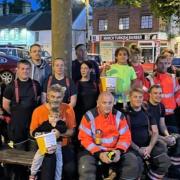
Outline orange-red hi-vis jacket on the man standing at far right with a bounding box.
[143,73,180,115]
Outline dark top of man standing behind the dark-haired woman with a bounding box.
[72,59,100,83]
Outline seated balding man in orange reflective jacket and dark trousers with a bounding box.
[78,92,139,180]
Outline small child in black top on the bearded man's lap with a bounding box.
[29,108,67,180]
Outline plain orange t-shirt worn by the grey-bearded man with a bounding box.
[30,103,76,146]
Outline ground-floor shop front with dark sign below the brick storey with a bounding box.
[91,33,168,63]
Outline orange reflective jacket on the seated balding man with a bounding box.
[78,108,131,154]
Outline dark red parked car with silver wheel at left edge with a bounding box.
[0,55,18,84]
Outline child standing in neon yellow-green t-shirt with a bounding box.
[102,47,136,110]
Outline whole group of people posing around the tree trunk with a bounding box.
[0,44,180,180]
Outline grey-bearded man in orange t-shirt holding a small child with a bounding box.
[30,84,76,180]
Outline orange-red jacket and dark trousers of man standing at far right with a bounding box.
[143,72,180,133]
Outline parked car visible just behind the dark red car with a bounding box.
[0,46,29,59]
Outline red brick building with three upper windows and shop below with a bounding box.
[91,5,168,61]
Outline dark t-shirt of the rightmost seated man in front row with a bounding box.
[147,102,165,132]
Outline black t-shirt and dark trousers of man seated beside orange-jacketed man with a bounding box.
[126,106,171,180]
